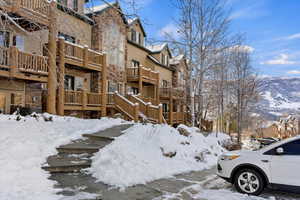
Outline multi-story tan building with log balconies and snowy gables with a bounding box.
[0,0,187,124]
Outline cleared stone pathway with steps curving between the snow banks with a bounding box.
[43,125,300,200]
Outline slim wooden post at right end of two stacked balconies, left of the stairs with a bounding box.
[99,54,107,117]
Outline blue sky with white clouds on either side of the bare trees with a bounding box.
[91,0,300,77]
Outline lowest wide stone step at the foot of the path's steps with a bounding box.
[42,153,92,173]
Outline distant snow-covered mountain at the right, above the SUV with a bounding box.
[255,78,300,120]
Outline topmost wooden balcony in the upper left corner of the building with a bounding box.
[2,0,50,27]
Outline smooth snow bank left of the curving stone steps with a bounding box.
[0,114,127,200]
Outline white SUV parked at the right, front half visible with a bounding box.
[217,136,300,195]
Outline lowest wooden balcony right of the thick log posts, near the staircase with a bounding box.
[64,90,102,111]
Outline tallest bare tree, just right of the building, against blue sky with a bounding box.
[166,0,230,125]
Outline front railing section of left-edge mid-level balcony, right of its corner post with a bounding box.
[18,51,48,75]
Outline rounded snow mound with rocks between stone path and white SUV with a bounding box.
[89,124,228,189]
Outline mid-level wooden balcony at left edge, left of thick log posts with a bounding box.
[0,46,48,82]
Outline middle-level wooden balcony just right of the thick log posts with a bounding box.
[55,40,103,71]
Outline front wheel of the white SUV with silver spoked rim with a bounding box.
[234,169,265,195]
